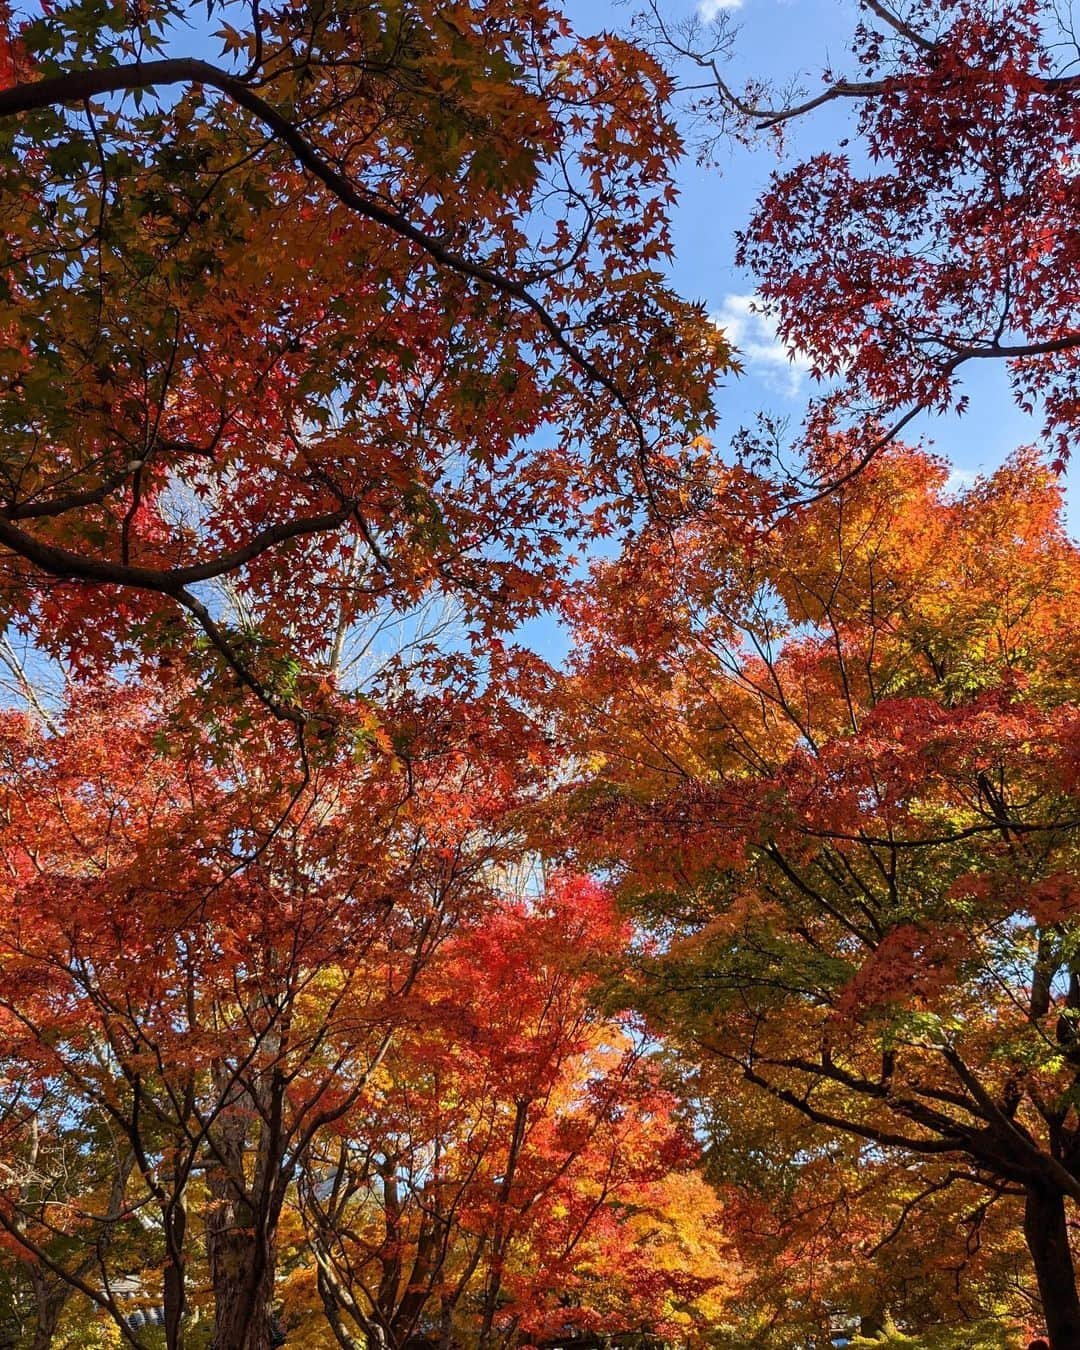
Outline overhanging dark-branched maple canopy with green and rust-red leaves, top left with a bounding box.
[0,0,726,721]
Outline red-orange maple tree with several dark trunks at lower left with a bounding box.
[0,675,556,1350]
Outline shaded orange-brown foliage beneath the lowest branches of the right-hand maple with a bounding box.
[684,1090,1031,1350]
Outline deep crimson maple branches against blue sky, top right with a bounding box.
[648,0,1080,479]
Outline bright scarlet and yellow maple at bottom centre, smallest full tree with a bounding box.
[291,878,737,1350]
